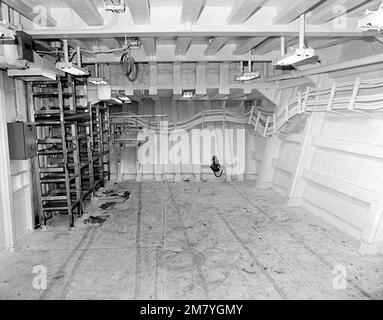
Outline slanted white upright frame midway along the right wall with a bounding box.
[287,112,326,207]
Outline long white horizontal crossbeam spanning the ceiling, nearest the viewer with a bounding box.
[28,21,376,39]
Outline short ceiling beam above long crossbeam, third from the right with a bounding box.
[226,0,268,24]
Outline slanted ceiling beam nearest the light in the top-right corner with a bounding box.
[307,0,370,24]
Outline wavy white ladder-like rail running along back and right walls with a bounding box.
[111,78,383,138]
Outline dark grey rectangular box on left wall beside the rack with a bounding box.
[8,122,37,160]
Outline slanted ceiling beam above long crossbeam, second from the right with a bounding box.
[273,0,325,24]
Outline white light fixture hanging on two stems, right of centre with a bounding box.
[274,14,316,67]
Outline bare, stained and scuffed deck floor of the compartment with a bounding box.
[0,182,383,300]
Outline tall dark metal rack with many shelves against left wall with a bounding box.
[30,76,110,227]
